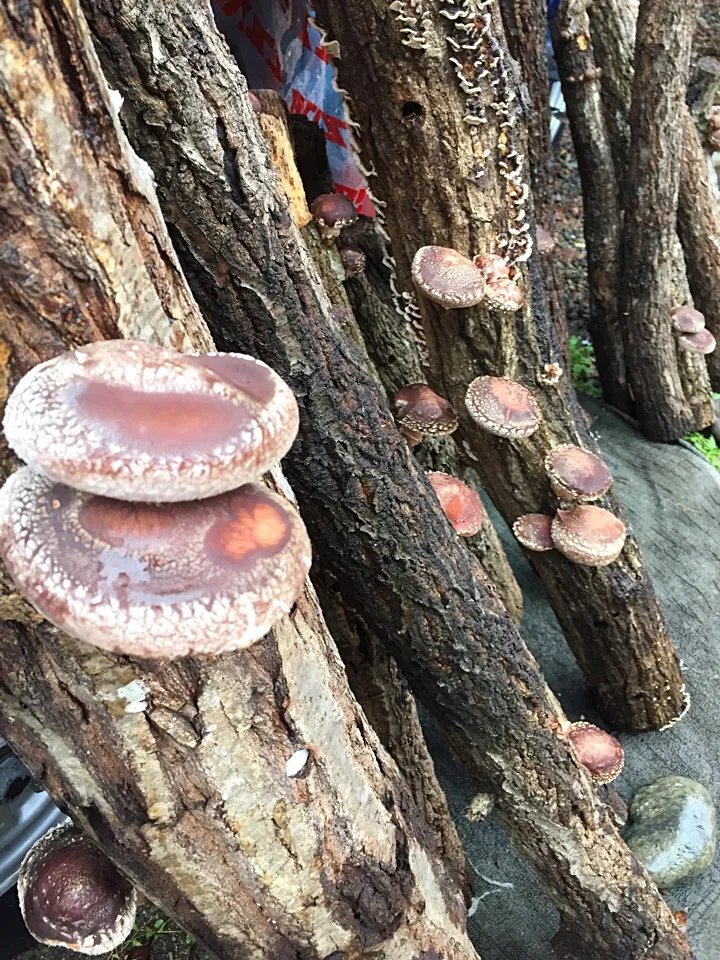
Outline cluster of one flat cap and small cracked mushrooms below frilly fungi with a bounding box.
[412,246,523,313]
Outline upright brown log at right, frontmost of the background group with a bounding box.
[618,0,715,441]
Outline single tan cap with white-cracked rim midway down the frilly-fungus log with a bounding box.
[465,377,540,440]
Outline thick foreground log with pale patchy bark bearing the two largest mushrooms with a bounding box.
[0,0,476,960]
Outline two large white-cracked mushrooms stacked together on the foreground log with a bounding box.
[0,341,310,658]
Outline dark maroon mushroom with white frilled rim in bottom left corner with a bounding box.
[18,824,137,955]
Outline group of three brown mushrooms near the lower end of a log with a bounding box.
[513,444,627,567]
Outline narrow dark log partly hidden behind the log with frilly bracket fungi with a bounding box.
[500,0,570,370]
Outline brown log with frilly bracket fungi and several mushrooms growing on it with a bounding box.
[317,0,683,730]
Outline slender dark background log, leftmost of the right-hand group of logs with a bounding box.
[553,7,632,412]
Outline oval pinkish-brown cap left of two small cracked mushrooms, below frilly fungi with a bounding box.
[412,247,485,310]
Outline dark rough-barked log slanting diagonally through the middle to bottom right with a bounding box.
[80,0,689,948]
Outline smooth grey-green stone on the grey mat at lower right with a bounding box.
[625,776,716,890]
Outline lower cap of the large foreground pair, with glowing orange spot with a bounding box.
[0,467,311,658]
